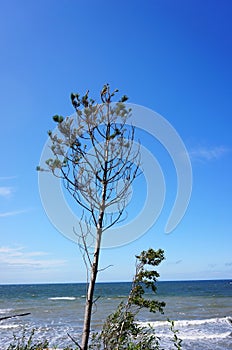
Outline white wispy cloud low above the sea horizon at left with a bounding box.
[0,247,66,269]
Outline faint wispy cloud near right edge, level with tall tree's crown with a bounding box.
[188,146,231,161]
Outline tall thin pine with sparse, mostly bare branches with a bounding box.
[37,84,140,350]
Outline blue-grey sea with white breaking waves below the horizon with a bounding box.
[0,280,232,350]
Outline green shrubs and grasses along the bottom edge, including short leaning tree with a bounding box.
[7,248,182,350]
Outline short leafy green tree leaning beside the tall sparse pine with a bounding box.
[91,248,167,350]
